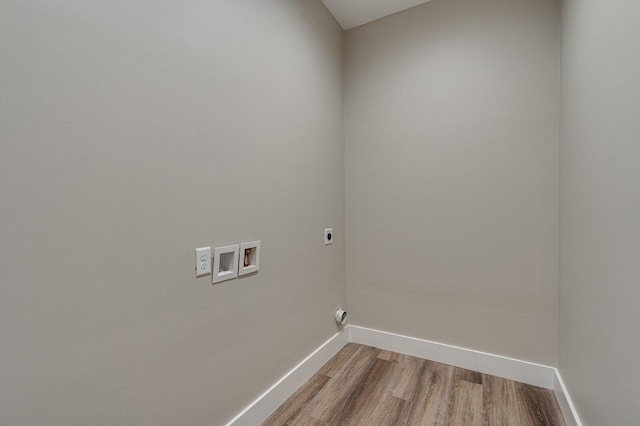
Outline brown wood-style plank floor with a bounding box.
[263,343,565,426]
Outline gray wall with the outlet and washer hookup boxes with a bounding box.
[0,0,346,425]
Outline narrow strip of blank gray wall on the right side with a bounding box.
[559,0,640,426]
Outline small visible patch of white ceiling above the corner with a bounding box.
[322,0,431,30]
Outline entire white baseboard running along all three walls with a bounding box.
[226,325,582,426]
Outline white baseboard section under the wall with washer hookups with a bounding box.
[222,331,349,426]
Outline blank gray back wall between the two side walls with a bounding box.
[345,0,559,365]
